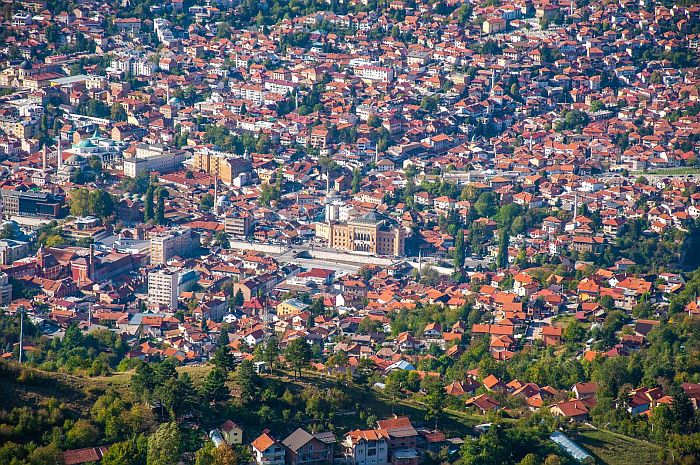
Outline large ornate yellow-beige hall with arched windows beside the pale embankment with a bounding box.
[316,212,406,257]
